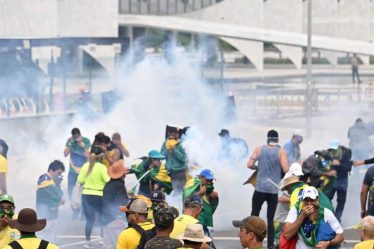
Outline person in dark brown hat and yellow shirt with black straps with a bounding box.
[3,208,58,249]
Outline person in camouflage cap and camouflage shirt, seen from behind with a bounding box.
[145,207,182,249]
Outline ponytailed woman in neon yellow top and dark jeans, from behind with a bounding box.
[78,146,110,248]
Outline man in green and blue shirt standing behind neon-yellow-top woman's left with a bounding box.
[64,128,91,218]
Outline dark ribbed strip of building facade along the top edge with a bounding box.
[119,0,223,15]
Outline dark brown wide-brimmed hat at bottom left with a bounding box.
[8,208,47,232]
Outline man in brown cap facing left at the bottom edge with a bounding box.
[232,216,267,249]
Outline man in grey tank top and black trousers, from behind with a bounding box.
[247,130,288,248]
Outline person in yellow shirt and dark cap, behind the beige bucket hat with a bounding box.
[170,194,204,239]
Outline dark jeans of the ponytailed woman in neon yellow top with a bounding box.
[82,194,103,240]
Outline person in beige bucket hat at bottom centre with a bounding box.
[178,224,212,249]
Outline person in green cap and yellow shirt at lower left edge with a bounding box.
[0,195,21,248]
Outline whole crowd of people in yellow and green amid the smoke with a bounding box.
[0,119,374,249]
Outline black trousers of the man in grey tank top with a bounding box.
[251,190,278,248]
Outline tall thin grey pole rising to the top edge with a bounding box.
[306,0,312,137]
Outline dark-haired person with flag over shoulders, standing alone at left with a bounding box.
[36,160,65,241]
